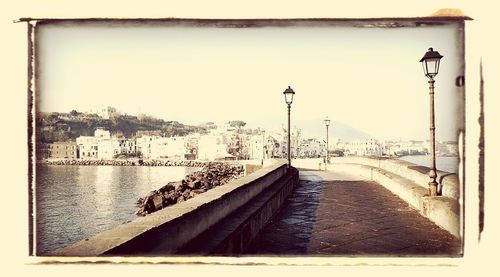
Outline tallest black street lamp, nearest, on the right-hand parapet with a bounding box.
[420,48,443,196]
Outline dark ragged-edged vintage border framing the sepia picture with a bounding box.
[20,8,480,264]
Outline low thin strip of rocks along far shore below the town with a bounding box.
[43,159,210,167]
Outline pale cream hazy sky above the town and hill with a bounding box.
[37,24,460,140]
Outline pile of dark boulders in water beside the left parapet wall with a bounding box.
[136,162,244,216]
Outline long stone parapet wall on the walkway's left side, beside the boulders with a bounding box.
[48,162,289,256]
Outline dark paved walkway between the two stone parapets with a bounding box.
[245,171,461,256]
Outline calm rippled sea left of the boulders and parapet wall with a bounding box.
[35,165,199,254]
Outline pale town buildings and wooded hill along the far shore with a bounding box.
[36,106,458,161]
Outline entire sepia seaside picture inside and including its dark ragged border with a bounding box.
[25,10,470,257]
